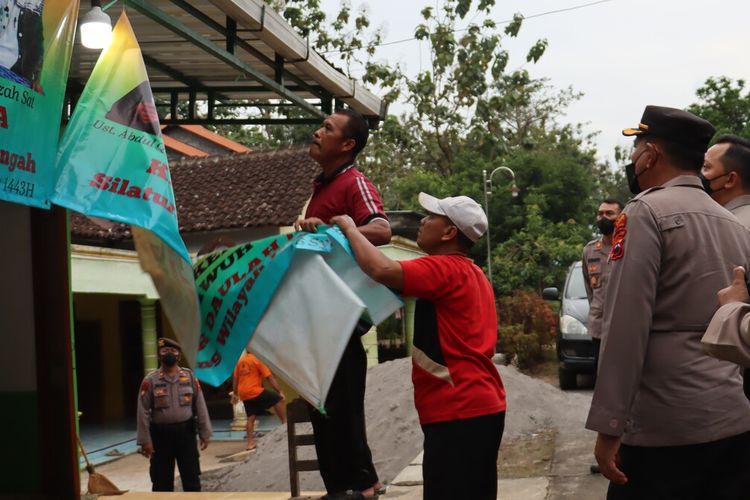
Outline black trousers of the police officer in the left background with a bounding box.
[149,419,201,491]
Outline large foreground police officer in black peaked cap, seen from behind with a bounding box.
[586,106,750,500]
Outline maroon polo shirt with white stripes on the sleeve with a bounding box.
[305,163,388,226]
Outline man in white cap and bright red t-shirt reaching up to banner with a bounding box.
[331,193,505,500]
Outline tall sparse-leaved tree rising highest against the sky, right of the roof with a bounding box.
[364,0,547,176]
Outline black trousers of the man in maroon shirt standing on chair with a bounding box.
[310,333,378,494]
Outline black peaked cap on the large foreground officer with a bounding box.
[622,106,716,151]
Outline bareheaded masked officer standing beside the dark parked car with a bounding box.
[583,198,623,376]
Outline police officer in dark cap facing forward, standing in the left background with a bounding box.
[137,338,212,491]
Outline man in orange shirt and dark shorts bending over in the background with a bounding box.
[232,351,286,451]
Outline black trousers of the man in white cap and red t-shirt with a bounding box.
[422,412,505,500]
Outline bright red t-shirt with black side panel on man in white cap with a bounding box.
[399,255,505,424]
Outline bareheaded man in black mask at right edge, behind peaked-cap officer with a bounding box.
[701,135,750,399]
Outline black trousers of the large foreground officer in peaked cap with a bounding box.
[607,432,750,500]
